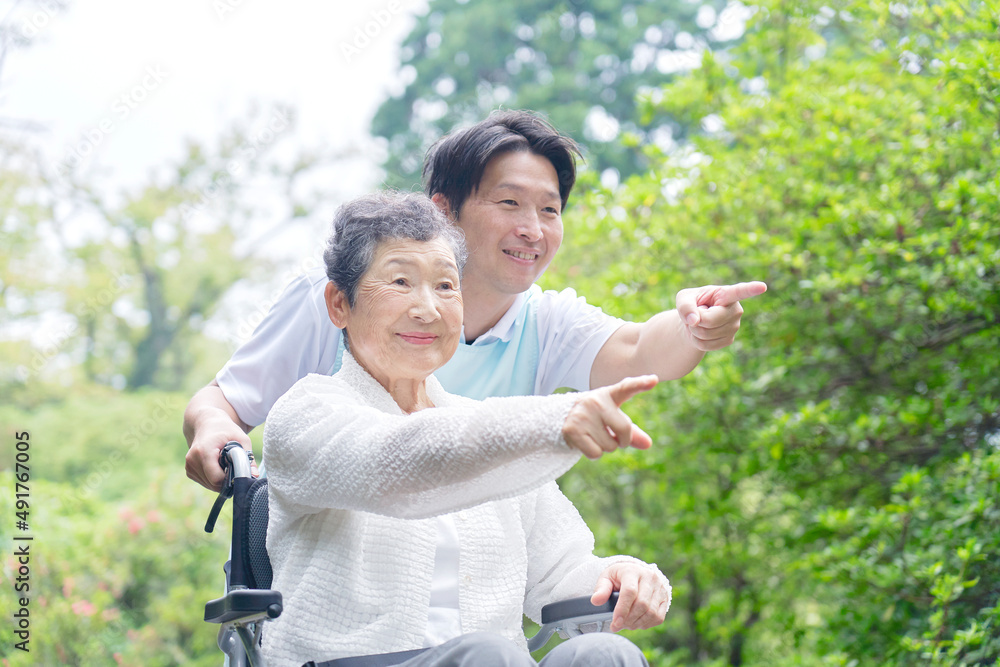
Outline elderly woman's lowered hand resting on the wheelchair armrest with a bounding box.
[590,562,670,632]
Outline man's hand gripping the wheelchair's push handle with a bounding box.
[184,380,257,491]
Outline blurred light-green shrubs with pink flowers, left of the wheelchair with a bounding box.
[0,387,260,667]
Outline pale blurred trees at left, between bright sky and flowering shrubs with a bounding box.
[0,109,334,392]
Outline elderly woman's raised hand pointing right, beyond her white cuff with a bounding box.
[562,375,658,459]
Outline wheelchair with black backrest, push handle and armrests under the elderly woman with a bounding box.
[205,442,618,667]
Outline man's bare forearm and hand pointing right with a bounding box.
[590,282,767,387]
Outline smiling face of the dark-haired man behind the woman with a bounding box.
[457,152,563,298]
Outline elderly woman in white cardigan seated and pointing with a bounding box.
[264,194,670,667]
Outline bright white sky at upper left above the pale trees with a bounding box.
[0,0,426,198]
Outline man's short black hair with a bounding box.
[423,110,580,216]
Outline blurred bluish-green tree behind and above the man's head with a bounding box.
[372,0,738,189]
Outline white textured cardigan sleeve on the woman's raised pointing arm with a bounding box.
[264,375,580,519]
